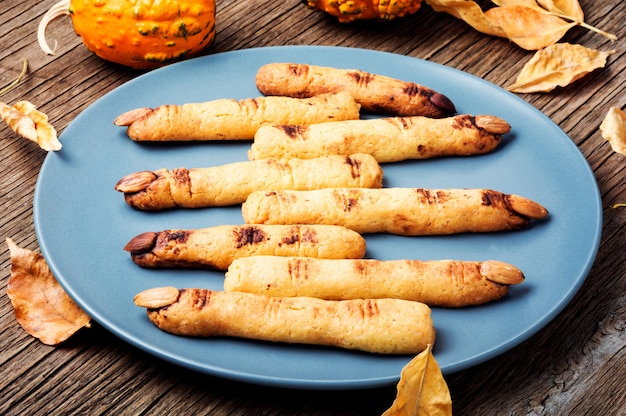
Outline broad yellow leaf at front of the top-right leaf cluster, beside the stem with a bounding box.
[485,6,576,50]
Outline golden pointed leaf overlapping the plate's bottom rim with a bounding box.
[382,345,452,416]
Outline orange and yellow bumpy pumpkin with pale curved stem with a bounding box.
[37,0,215,69]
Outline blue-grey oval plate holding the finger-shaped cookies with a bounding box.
[34,46,602,389]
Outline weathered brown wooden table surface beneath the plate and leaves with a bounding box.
[0,0,626,416]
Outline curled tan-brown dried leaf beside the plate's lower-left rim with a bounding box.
[6,238,91,345]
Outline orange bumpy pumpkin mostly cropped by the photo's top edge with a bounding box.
[302,0,422,23]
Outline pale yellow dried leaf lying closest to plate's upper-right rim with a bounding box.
[507,43,615,93]
